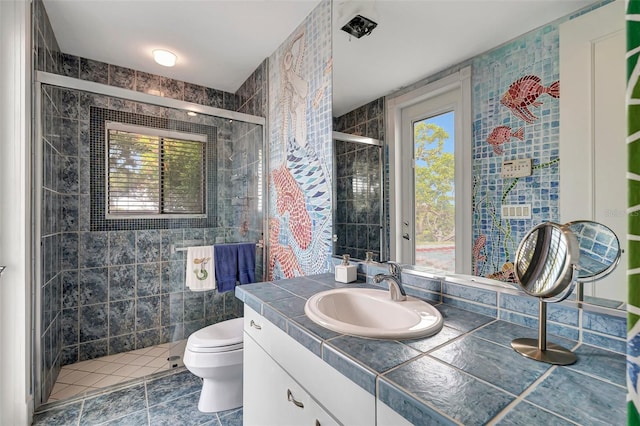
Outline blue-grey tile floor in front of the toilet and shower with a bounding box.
[32,367,243,426]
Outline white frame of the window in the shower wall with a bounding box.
[104,120,209,220]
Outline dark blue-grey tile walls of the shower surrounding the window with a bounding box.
[32,0,267,404]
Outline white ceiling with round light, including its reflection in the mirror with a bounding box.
[44,0,594,116]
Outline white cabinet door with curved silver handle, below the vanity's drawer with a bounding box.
[243,333,338,426]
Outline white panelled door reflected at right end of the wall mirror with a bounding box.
[560,1,627,301]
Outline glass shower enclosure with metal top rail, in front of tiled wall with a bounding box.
[33,72,265,406]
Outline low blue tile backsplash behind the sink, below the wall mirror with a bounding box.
[359,270,627,354]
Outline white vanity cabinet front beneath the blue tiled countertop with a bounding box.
[243,305,376,426]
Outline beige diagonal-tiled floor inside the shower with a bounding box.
[47,342,184,403]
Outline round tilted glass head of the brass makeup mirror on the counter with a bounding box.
[515,222,580,302]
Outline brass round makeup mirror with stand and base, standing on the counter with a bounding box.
[511,222,580,365]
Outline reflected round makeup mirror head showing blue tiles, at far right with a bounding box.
[566,220,622,282]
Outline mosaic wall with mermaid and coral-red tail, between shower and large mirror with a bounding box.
[268,0,333,279]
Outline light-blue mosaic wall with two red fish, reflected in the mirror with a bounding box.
[472,24,560,279]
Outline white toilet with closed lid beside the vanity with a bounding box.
[184,318,243,413]
